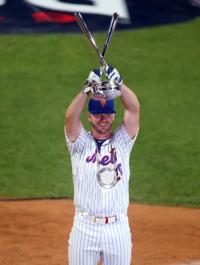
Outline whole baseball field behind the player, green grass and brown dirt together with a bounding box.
[0,19,200,265]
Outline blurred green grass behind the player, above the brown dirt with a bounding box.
[0,19,200,207]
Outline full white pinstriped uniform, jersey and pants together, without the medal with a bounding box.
[65,123,137,265]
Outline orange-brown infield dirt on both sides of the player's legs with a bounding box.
[0,200,200,265]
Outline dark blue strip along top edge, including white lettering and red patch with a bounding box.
[0,0,200,33]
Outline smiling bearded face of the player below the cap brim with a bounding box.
[88,114,115,134]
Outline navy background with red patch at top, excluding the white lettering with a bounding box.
[0,0,200,33]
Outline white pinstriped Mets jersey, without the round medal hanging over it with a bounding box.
[65,123,137,216]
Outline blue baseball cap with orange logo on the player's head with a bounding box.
[88,98,116,114]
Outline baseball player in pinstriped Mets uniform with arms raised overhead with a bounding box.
[65,66,140,265]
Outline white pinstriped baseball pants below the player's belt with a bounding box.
[68,212,132,265]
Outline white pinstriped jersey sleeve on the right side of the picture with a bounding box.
[114,123,139,153]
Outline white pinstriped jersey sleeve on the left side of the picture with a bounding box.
[64,127,88,155]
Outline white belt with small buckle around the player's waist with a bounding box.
[76,210,127,224]
